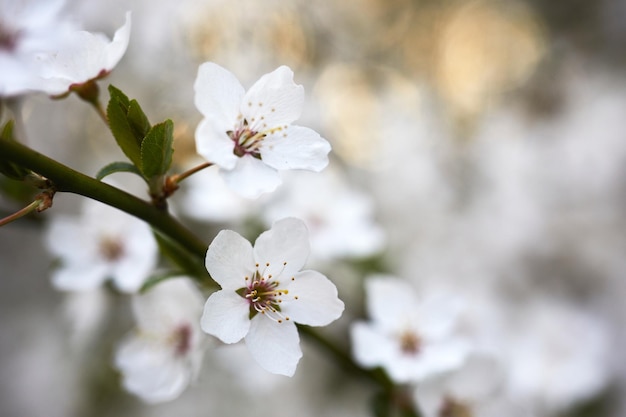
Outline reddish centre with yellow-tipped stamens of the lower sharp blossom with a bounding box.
[237,263,290,323]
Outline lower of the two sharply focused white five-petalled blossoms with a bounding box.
[201,218,344,376]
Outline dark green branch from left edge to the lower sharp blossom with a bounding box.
[0,140,208,258]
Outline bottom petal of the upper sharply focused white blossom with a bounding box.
[220,155,281,198]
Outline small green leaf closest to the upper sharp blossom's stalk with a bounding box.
[141,120,174,178]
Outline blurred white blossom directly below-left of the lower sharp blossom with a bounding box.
[115,277,206,403]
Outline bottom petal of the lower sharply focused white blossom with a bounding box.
[245,314,302,376]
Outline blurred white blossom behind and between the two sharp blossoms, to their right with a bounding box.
[265,170,385,259]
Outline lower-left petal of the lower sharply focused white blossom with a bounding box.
[200,290,250,343]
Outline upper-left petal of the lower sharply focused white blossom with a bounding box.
[205,230,254,290]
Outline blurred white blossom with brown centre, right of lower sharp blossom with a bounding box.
[351,276,470,383]
